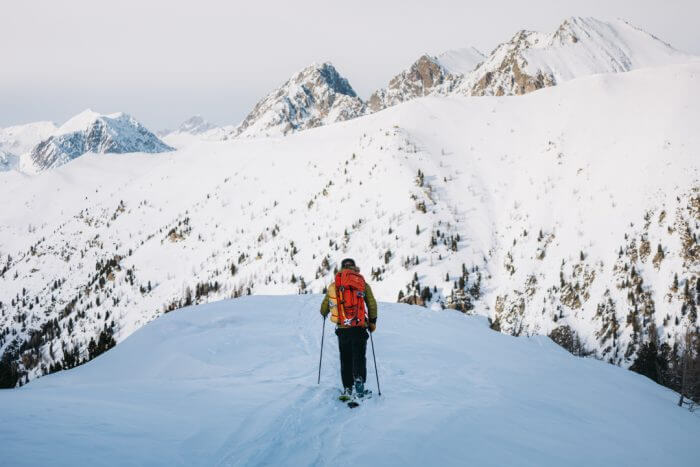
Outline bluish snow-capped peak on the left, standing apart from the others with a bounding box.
[29,109,172,170]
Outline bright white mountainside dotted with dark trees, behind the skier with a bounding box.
[0,62,700,388]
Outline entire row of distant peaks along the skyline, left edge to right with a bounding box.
[0,17,691,172]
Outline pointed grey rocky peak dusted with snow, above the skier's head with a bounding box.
[235,63,365,137]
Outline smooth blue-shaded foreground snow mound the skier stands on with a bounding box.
[0,295,700,467]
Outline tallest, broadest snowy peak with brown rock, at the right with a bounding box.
[459,17,691,96]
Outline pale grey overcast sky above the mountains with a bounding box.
[0,0,700,130]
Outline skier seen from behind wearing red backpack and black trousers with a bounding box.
[321,258,377,401]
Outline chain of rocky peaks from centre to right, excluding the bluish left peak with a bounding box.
[160,17,690,140]
